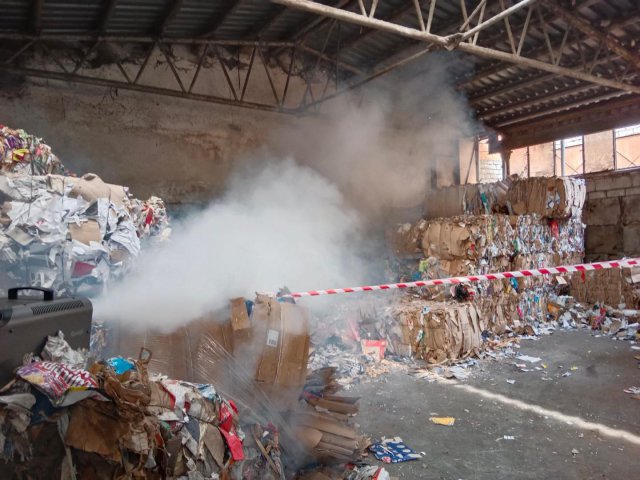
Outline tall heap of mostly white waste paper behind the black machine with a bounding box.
[0,126,170,295]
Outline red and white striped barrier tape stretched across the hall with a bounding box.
[282,258,640,298]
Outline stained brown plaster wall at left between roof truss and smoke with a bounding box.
[0,82,287,203]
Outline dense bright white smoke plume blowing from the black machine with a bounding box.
[95,158,363,332]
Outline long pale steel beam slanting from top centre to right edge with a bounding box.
[272,0,640,93]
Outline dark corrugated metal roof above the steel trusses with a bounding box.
[0,0,640,137]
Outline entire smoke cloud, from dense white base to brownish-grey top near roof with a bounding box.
[95,52,470,331]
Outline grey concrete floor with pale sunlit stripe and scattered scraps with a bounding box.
[349,331,640,480]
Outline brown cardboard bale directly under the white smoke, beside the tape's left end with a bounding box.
[111,296,309,411]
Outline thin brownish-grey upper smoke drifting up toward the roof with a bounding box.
[273,53,473,221]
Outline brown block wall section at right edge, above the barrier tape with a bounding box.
[583,169,640,261]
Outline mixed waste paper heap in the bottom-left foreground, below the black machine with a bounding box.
[0,335,276,479]
